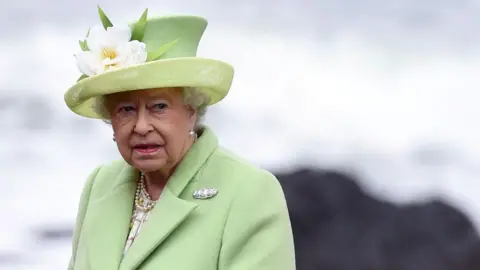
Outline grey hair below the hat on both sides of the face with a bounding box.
[93,87,210,129]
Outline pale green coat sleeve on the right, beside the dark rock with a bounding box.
[218,171,295,270]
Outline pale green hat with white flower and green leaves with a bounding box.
[65,7,234,118]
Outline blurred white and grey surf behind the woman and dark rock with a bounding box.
[0,0,480,270]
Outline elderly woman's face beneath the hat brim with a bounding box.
[105,88,196,172]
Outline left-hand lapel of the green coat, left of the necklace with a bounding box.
[86,165,138,270]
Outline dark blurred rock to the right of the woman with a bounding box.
[275,169,480,270]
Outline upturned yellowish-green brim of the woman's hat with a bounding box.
[64,57,234,119]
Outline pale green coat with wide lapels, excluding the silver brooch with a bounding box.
[68,128,295,270]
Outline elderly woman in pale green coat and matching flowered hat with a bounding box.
[65,8,295,270]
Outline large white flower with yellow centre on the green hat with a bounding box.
[75,25,147,76]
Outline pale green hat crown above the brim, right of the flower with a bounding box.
[137,15,207,60]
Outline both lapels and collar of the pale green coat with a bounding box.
[87,127,218,270]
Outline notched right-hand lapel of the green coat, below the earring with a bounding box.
[121,128,218,269]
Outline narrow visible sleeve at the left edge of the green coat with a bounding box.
[68,166,101,270]
